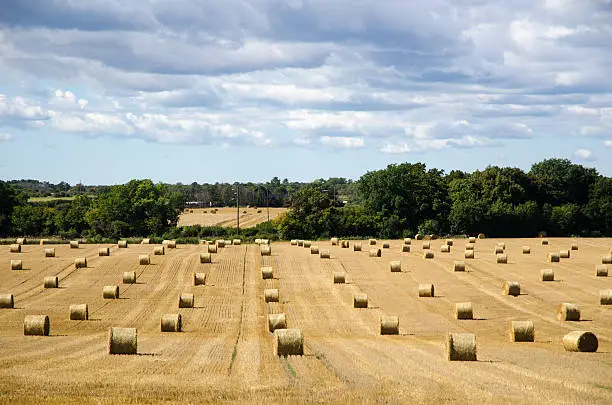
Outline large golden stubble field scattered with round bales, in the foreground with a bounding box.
[0,235,612,404]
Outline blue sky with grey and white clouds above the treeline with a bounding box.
[0,0,612,184]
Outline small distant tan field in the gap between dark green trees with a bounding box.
[178,207,287,228]
